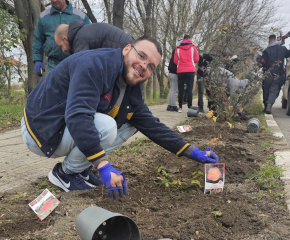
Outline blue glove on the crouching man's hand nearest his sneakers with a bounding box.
[98,163,128,199]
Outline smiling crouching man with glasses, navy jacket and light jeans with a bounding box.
[21,37,218,199]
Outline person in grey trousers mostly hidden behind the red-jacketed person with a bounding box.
[166,38,183,112]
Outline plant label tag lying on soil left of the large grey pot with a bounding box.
[28,189,60,221]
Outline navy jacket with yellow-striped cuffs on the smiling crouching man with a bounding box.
[24,48,190,161]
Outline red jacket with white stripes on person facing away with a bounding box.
[174,39,199,73]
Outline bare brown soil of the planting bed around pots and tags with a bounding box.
[0,118,290,240]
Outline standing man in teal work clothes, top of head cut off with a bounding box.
[32,0,91,76]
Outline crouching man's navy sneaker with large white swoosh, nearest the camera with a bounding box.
[48,163,93,192]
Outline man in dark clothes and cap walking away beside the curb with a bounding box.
[261,35,290,114]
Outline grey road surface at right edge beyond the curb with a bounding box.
[272,91,290,146]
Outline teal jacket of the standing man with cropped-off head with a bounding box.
[32,1,91,61]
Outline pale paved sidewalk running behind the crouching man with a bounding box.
[0,99,195,192]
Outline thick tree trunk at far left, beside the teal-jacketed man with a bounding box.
[14,0,41,96]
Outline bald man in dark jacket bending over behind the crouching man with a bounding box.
[54,20,134,54]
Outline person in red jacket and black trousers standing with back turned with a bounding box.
[174,35,199,113]
